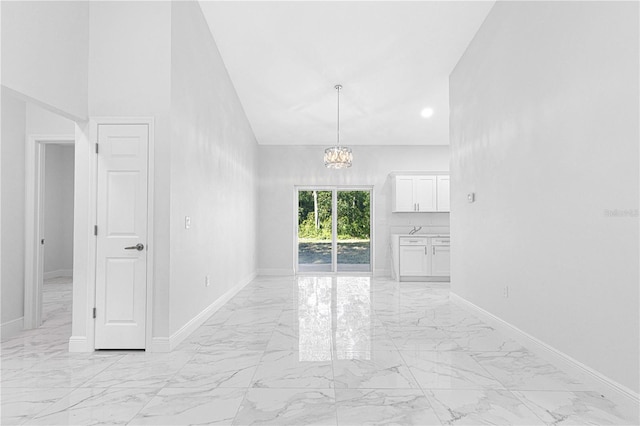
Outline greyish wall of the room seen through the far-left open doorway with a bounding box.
[43,144,74,279]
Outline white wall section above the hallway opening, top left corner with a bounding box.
[0,1,89,119]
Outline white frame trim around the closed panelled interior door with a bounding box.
[84,117,155,351]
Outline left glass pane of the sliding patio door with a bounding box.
[298,190,333,272]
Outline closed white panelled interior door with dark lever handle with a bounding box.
[95,124,149,349]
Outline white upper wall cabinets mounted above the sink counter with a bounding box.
[391,175,449,213]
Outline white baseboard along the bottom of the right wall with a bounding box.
[451,293,640,406]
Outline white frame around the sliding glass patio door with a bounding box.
[293,185,376,276]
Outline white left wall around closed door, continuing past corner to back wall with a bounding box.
[82,2,257,339]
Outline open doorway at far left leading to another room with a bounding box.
[24,136,75,334]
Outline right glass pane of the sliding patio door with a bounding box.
[336,190,371,272]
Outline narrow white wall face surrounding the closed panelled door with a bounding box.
[85,2,171,337]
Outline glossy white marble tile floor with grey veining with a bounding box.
[0,277,638,425]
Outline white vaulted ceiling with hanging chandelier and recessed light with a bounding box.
[200,0,494,145]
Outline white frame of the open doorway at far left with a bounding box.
[23,135,76,330]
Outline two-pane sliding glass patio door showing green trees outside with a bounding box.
[295,187,373,273]
